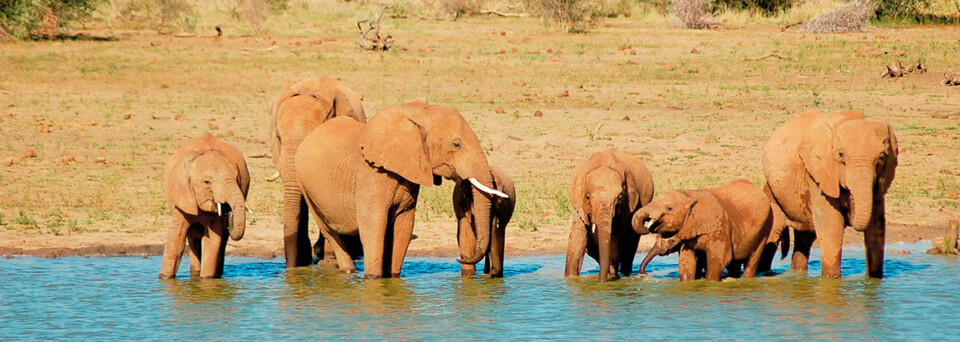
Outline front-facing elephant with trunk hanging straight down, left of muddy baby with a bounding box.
[564,148,653,283]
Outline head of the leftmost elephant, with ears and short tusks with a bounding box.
[164,134,250,240]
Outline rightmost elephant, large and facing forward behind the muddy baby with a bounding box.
[763,110,899,278]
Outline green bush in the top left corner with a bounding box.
[0,0,101,39]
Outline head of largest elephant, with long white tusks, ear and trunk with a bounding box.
[359,102,507,264]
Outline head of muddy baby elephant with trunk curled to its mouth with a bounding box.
[632,191,723,242]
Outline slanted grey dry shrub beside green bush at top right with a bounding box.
[799,0,877,33]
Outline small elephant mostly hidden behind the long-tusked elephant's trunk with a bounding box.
[453,167,517,278]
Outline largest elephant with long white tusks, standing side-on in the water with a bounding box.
[294,102,508,279]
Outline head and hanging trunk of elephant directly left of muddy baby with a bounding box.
[570,149,641,282]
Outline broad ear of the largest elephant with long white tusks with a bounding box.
[359,107,433,185]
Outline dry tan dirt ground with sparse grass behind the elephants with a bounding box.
[0,8,960,257]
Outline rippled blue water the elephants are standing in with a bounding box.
[0,243,960,341]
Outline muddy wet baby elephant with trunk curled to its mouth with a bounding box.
[633,179,773,280]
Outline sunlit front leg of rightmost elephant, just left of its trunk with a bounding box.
[811,196,845,279]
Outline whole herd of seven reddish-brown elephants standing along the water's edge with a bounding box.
[160,76,898,282]
